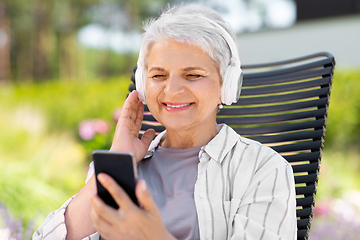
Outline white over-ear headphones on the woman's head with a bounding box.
[135,18,243,105]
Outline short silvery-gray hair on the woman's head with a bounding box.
[140,4,236,79]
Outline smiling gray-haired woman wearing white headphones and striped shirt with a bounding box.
[33,5,297,240]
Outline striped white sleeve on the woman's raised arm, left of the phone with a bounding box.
[32,162,99,240]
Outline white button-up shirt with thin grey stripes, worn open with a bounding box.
[33,124,297,240]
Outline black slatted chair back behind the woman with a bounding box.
[129,52,335,239]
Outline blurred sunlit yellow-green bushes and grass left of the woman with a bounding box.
[0,76,130,229]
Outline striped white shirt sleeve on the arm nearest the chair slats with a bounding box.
[231,156,297,240]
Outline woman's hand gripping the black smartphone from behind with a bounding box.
[91,173,174,240]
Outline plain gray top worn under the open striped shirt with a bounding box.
[138,146,201,239]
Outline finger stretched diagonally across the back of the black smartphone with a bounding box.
[98,173,134,211]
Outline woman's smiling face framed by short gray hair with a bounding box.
[146,40,221,131]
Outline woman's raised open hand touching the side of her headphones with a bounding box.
[110,91,155,162]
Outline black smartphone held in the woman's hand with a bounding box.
[92,150,139,209]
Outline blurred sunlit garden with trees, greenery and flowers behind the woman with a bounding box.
[0,0,360,239]
